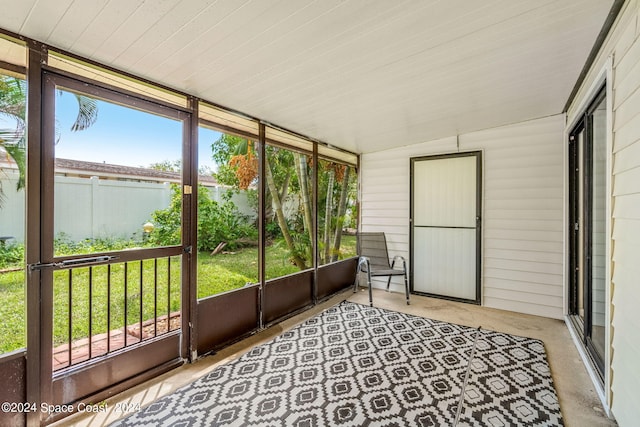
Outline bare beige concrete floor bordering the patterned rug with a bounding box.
[54,290,617,427]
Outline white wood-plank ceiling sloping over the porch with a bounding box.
[0,0,613,153]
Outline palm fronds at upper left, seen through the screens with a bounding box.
[0,74,98,208]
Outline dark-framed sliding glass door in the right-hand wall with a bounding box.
[569,88,607,375]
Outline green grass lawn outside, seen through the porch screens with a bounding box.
[0,236,355,354]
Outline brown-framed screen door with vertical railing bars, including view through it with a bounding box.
[29,72,191,416]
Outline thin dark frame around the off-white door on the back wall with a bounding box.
[409,151,482,305]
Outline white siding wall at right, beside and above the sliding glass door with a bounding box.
[568,0,640,427]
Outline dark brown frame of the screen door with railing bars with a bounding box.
[27,68,197,425]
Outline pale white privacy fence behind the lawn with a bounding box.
[0,170,255,242]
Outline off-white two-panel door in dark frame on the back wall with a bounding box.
[411,152,481,303]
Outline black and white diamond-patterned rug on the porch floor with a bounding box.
[113,302,563,427]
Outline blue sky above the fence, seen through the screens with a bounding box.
[55,92,220,170]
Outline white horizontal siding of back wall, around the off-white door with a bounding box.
[361,115,564,318]
